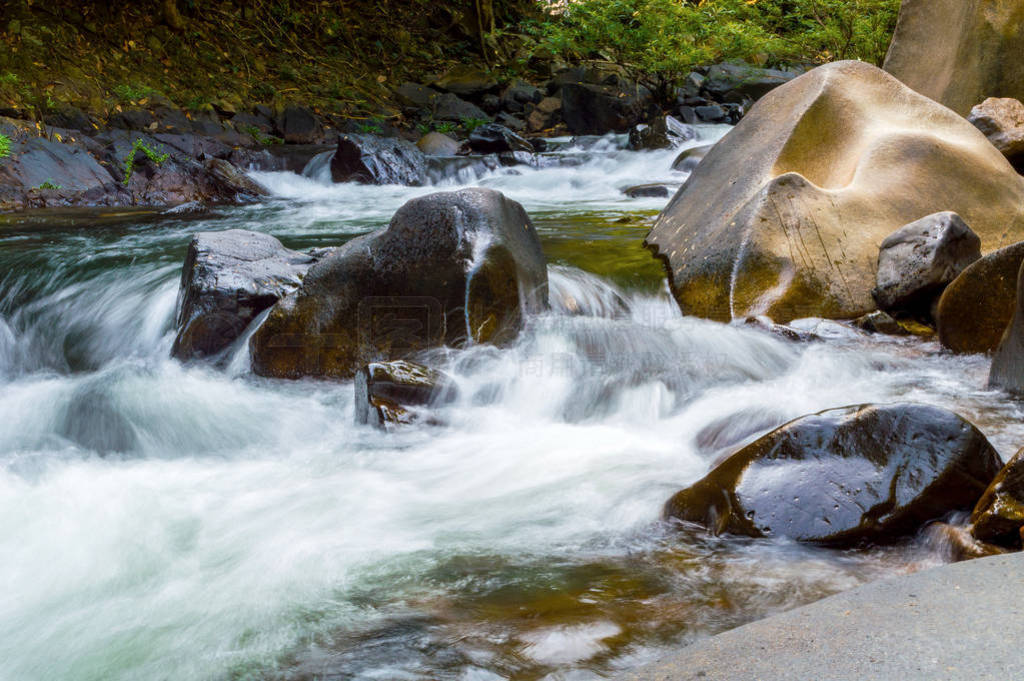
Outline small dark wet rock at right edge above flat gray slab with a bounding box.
[971,450,1024,548]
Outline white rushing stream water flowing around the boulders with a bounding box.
[0,128,1024,681]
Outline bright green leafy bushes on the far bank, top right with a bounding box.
[526,0,900,81]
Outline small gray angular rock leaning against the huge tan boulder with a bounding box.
[871,211,981,313]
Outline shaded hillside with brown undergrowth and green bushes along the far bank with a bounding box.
[0,0,899,118]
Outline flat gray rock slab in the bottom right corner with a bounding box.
[620,553,1024,681]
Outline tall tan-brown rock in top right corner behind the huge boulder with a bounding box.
[885,0,1024,116]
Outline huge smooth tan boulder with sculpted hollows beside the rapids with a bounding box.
[647,61,1024,323]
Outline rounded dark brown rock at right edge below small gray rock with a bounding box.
[935,243,1024,352]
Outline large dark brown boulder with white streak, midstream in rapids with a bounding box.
[250,188,548,378]
